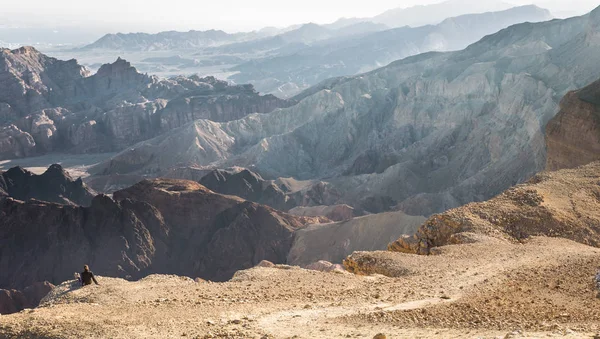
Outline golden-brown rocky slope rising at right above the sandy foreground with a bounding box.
[388,162,600,254]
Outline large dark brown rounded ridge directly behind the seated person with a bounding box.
[0,174,310,289]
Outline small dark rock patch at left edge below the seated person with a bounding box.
[0,281,54,315]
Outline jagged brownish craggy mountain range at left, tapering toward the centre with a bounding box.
[0,47,290,158]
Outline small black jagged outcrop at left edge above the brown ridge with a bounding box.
[0,164,96,206]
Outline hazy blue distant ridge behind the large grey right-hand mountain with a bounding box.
[231,5,552,95]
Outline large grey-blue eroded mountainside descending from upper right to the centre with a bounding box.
[96,9,600,215]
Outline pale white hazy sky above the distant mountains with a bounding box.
[0,0,598,32]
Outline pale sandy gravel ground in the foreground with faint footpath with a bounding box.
[0,238,600,338]
